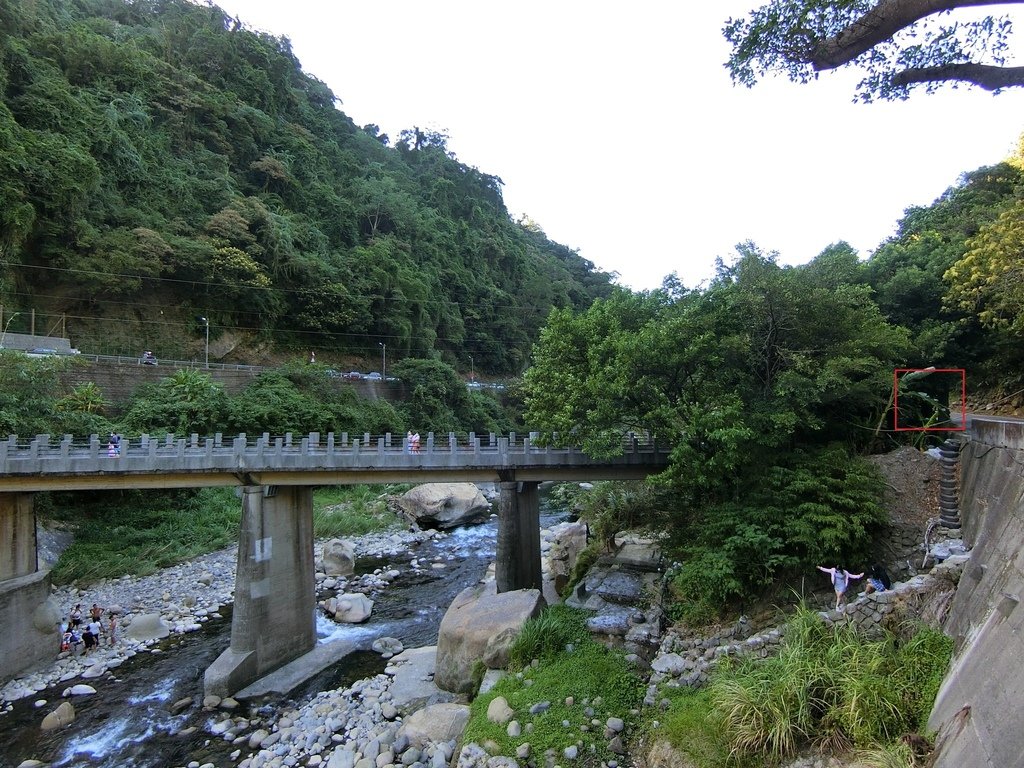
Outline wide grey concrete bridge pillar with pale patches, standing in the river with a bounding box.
[204,485,316,696]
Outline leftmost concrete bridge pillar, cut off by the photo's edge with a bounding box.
[0,493,60,683]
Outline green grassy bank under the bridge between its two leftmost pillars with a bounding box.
[50,488,242,586]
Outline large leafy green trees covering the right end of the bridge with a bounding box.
[525,244,908,613]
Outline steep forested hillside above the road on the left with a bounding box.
[0,0,610,373]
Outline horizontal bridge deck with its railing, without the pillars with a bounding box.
[0,432,668,492]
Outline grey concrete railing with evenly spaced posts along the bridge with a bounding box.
[0,432,666,474]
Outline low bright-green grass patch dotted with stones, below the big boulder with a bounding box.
[464,606,643,768]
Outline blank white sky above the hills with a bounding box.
[209,0,1024,290]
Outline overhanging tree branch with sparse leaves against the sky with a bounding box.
[723,0,1024,101]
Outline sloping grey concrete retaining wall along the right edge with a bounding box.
[929,421,1024,768]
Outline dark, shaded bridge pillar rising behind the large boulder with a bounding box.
[495,480,543,592]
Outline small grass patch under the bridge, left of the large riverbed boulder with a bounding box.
[313,485,410,539]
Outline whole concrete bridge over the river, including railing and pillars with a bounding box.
[0,433,668,695]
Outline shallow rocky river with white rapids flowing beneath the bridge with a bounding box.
[0,497,564,768]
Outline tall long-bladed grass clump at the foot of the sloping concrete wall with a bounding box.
[658,609,952,768]
